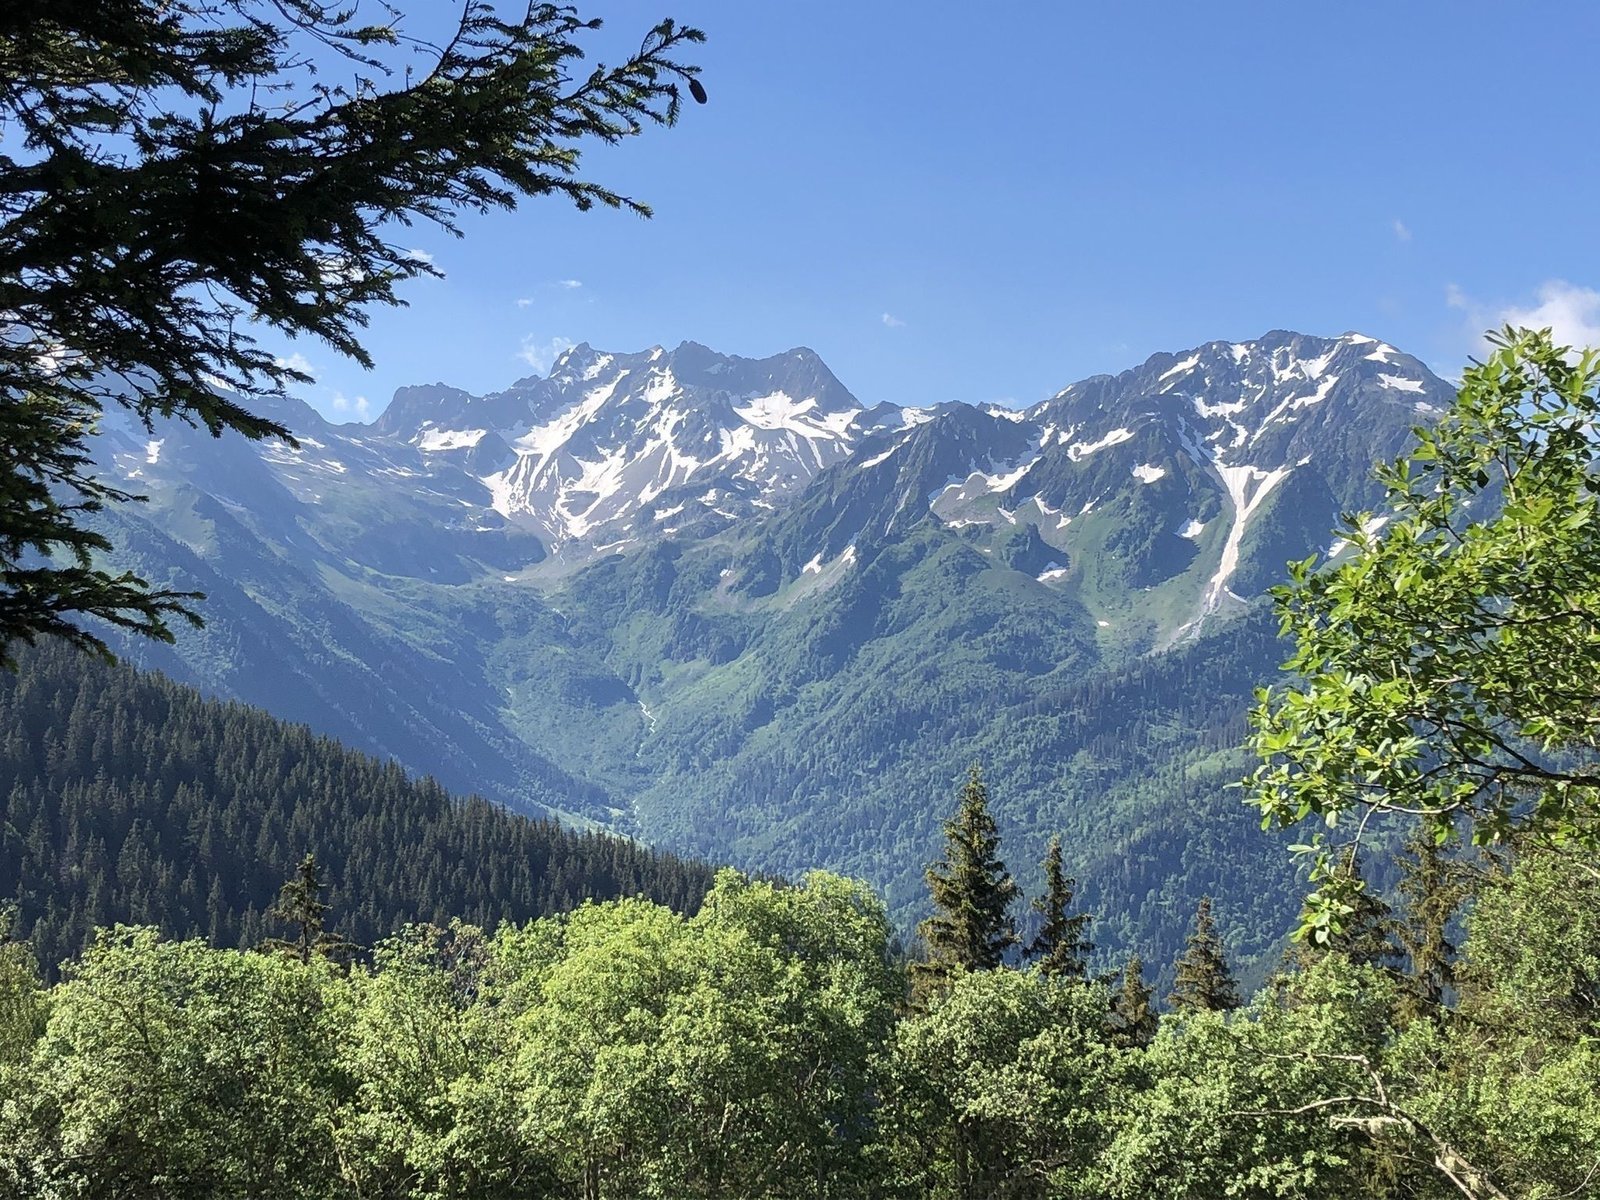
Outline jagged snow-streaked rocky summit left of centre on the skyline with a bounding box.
[374,342,894,552]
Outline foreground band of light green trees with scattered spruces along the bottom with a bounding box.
[0,773,1600,1200]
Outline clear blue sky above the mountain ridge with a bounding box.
[293,0,1600,419]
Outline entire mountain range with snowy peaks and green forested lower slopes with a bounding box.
[99,331,1453,979]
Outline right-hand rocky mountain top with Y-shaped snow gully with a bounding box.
[748,324,1451,643]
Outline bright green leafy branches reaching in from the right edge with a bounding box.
[1251,328,1600,939]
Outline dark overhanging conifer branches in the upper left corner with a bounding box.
[0,0,706,669]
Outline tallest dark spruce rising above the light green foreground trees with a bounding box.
[914,763,1018,984]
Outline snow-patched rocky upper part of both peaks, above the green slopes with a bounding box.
[246,330,1450,602]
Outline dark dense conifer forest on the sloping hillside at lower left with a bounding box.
[0,643,712,970]
